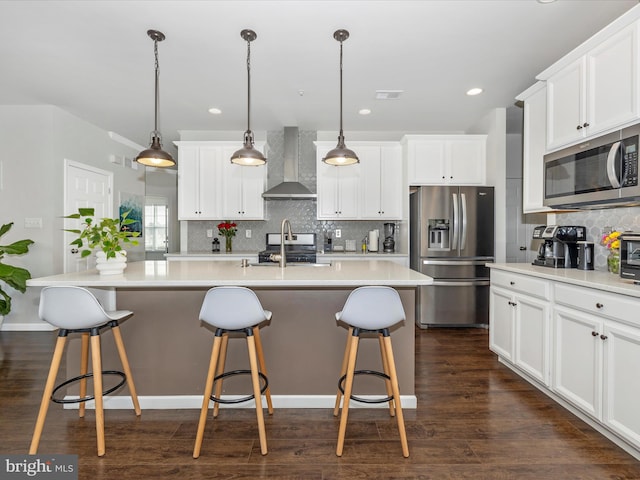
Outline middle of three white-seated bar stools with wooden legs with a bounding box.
[193,287,273,458]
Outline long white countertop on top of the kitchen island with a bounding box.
[27,260,433,288]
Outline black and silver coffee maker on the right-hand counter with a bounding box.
[532,225,587,268]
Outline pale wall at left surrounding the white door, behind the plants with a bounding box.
[0,106,145,330]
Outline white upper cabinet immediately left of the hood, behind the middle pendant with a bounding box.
[222,144,267,220]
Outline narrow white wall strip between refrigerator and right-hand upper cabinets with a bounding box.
[467,108,507,262]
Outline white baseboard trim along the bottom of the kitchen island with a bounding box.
[64,395,418,410]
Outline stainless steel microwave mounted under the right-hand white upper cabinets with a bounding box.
[544,125,640,209]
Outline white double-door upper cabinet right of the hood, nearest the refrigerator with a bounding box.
[354,144,403,220]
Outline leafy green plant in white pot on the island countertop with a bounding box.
[64,208,140,274]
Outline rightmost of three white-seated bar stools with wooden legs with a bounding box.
[333,286,409,457]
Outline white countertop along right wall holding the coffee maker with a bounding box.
[487,263,640,297]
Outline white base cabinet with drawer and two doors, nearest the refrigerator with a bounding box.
[489,271,551,386]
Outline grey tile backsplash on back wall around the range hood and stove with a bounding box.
[187,130,398,253]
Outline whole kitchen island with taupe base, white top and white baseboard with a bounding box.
[28,260,433,408]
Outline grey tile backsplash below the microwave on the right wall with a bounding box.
[556,207,640,268]
